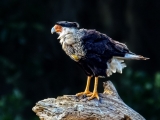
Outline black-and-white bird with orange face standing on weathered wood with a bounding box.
[51,21,149,100]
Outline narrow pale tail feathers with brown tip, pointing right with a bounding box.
[114,53,150,60]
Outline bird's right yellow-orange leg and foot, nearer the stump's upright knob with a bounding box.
[87,77,99,100]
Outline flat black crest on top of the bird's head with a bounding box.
[56,21,79,28]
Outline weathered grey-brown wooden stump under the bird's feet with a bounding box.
[32,81,145,120]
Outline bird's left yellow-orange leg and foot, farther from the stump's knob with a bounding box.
[76,76,92,96]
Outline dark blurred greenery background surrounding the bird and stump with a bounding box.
[0,0,160,120]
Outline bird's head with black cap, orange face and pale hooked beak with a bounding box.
[51,21,79,35]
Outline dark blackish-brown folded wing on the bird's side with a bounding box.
[81,30,130,58]
